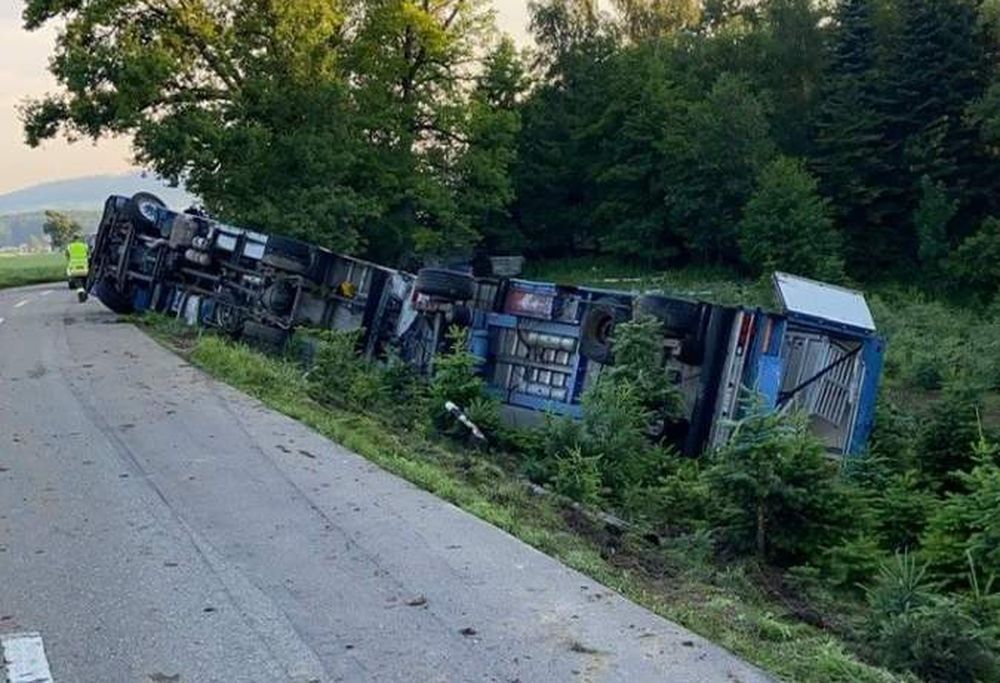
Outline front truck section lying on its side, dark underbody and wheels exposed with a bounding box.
[87,195,413,354]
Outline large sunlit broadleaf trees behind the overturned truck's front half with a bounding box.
[23,0,518,260]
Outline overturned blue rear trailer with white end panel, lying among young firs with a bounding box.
[471,273,884,455]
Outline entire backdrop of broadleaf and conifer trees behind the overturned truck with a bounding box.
[23,0,1000,300]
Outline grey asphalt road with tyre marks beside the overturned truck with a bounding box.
[0,286,768,683]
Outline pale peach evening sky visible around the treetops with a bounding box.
[0,0,540,194]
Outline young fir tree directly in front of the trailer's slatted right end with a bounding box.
[706,412,850,565]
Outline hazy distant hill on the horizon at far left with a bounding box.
[0,173,194,215]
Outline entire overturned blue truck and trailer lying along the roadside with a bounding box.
[87,194,884,456]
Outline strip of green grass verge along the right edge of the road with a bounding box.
[137,316,908,683]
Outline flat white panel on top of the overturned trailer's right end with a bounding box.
[774,273,875,332]
